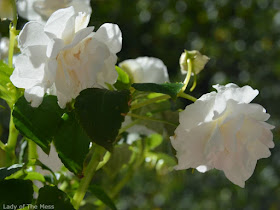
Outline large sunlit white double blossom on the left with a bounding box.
[10,7,122,108]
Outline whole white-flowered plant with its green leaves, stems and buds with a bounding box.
[0,1,274,210]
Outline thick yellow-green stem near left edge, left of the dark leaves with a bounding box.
[5,112,18,163]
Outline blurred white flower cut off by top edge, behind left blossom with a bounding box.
[17,0,91,23]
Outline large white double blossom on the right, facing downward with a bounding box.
[171,84,274,187]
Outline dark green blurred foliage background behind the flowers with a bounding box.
[0,0,280,210]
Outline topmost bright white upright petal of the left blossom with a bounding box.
[44,7,75,40]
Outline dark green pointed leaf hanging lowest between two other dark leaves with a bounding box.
[54,113,91,174]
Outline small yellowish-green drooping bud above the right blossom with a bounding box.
[179,50,210,74]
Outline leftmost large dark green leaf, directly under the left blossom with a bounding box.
[13,96,65,154]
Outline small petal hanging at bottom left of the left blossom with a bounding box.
[24,86,45,107]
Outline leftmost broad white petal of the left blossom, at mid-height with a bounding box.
[10,55,45,89]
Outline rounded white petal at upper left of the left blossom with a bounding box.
[18,21,50,52]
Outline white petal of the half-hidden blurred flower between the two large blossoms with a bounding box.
[136,57,169,84]
